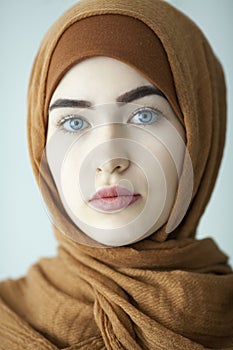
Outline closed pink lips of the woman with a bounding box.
[88,185,141,211]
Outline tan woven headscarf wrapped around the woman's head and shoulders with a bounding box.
[0,0,233,350]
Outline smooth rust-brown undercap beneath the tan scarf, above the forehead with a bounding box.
[44,14,183,122]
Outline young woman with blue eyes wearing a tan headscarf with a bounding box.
[0,0,233,349]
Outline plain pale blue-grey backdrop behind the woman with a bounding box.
[0,0,233,279]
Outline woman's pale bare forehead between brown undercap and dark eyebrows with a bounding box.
[51,56,153,103]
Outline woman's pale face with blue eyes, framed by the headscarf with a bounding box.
[46,57,185,246]
